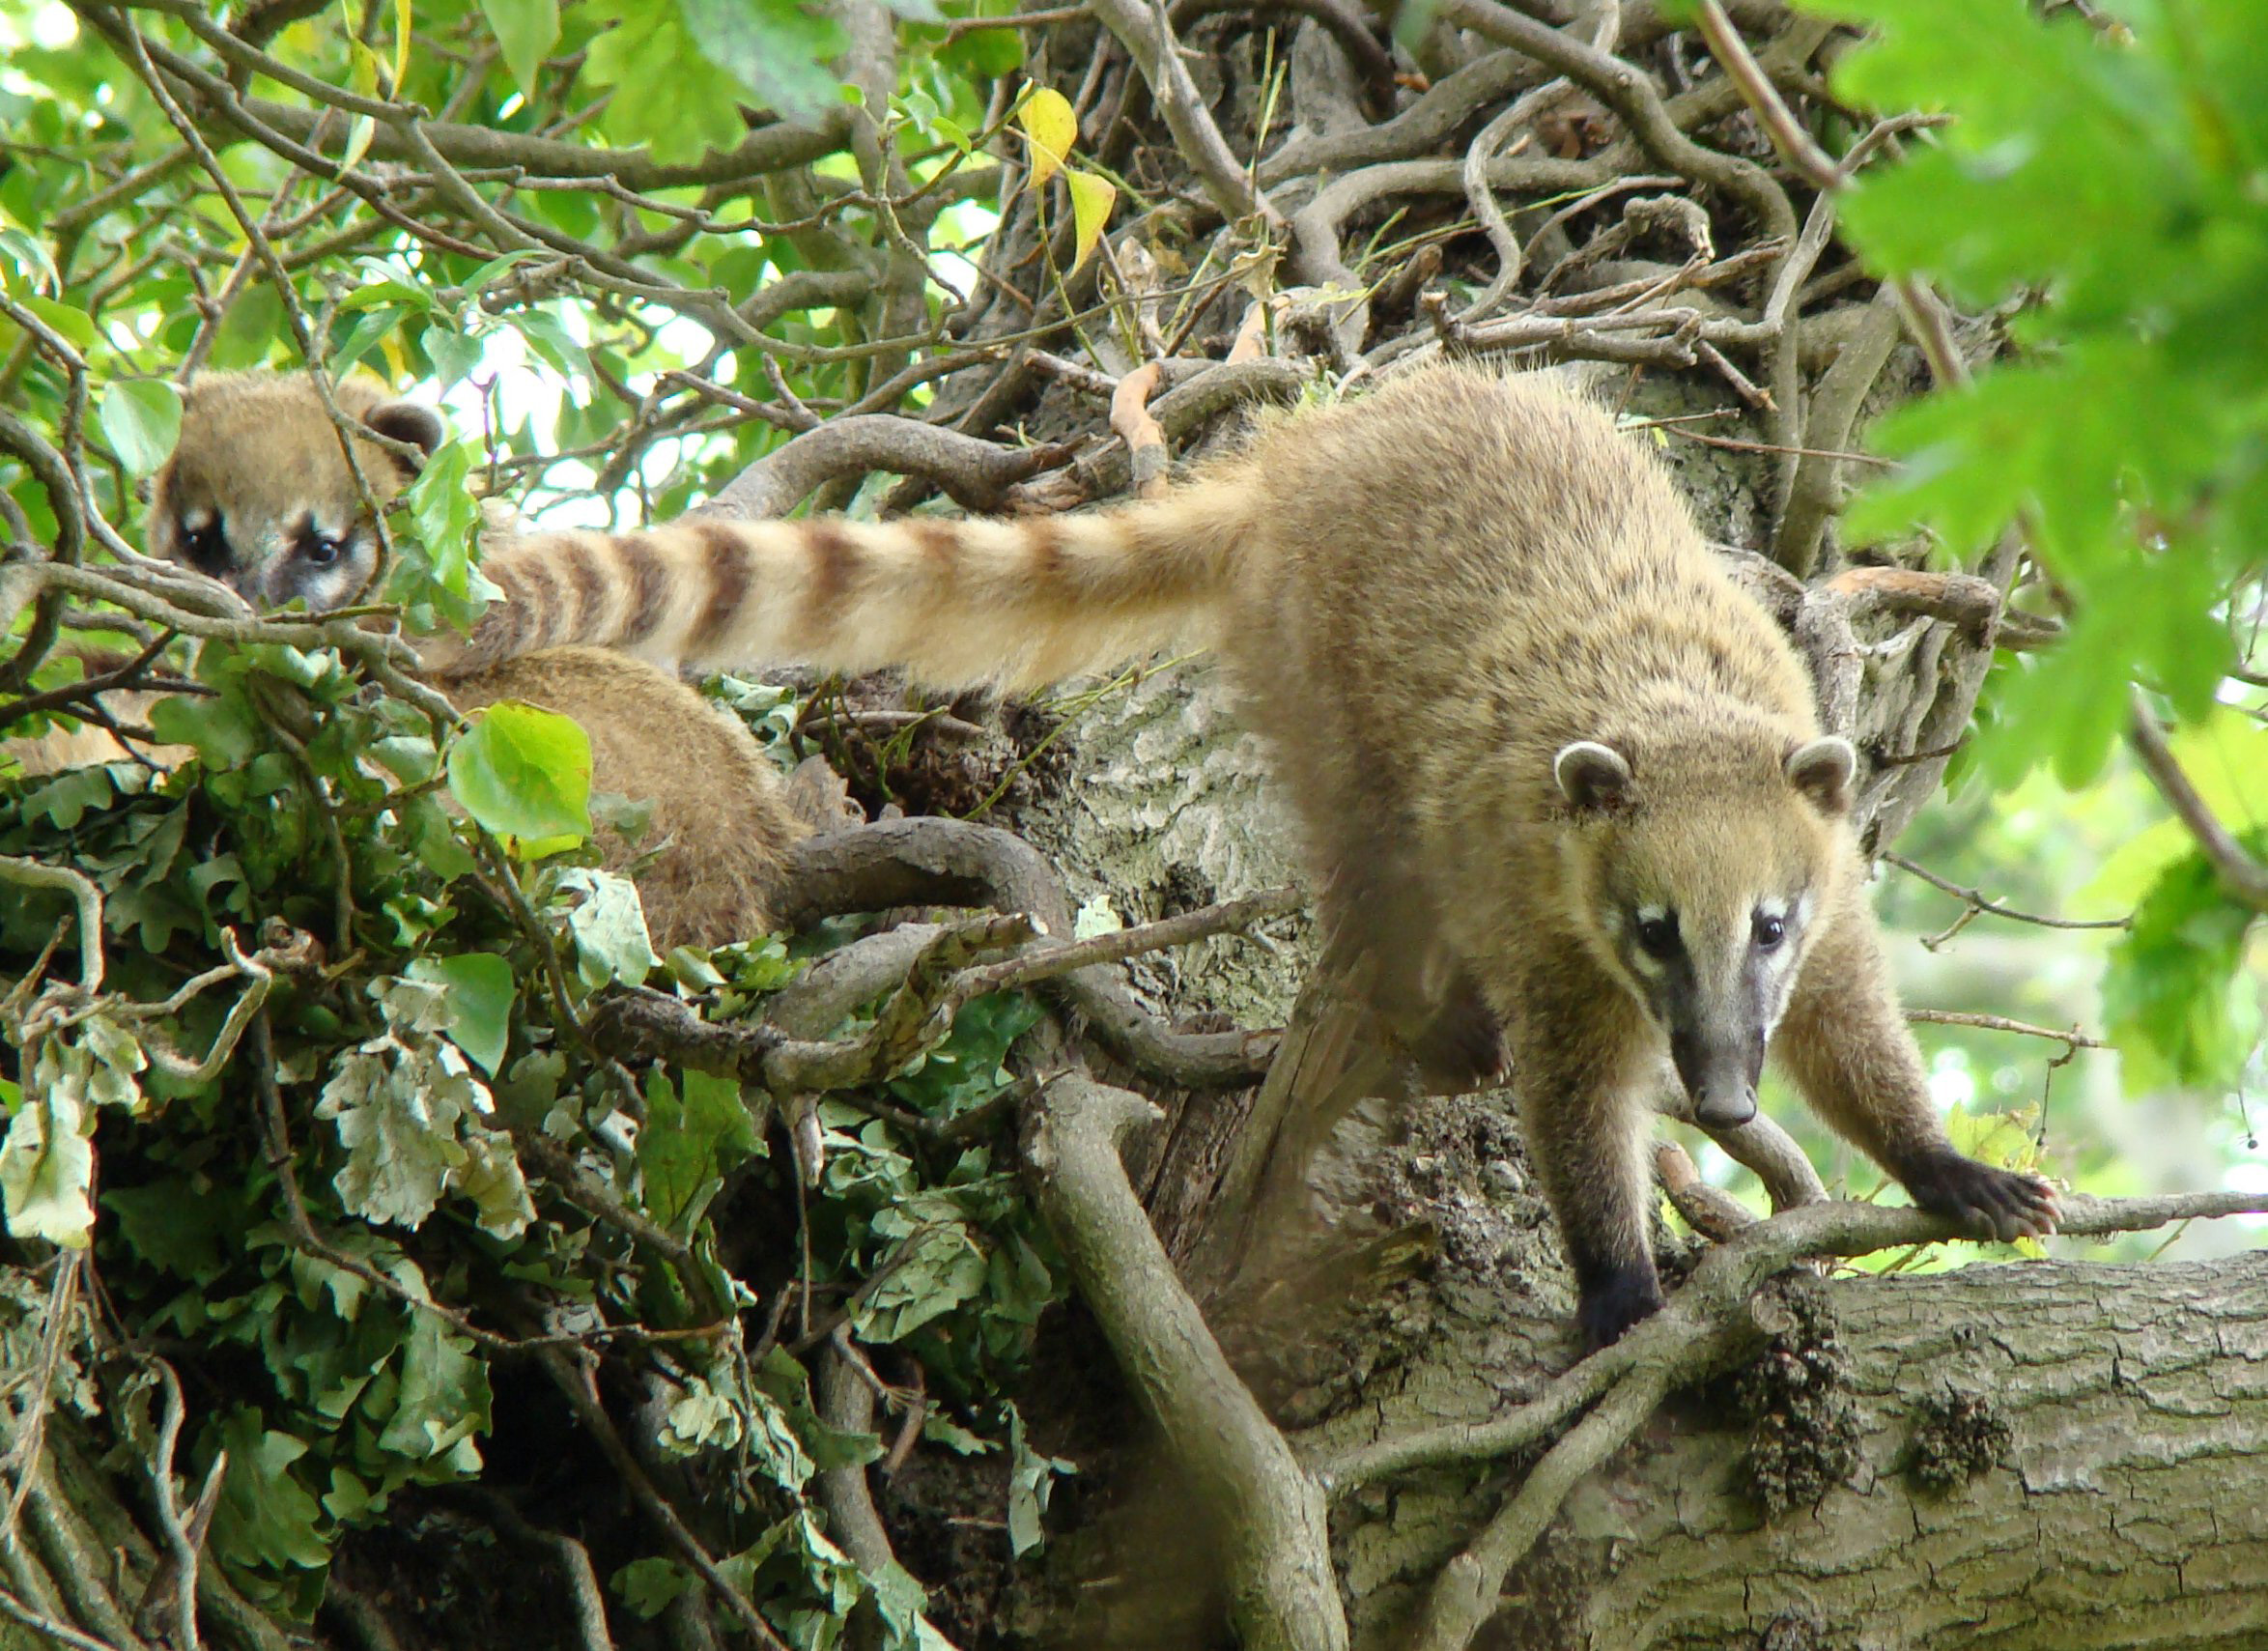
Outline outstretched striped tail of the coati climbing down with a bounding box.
[419,481,1250,690]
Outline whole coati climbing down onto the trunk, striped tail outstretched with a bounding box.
[403,365,2055,1347]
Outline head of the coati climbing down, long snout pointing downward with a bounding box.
[1553,737,1857,1127]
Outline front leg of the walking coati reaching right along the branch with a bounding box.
[1772,907,2055,1240]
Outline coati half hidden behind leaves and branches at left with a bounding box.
[9,372,808,951]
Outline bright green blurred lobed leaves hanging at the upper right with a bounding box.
[1817,0,2268,1120]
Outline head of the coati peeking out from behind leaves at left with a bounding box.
[148,372,447,612]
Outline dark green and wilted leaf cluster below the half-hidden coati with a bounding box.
[0,648,1060,1646]
